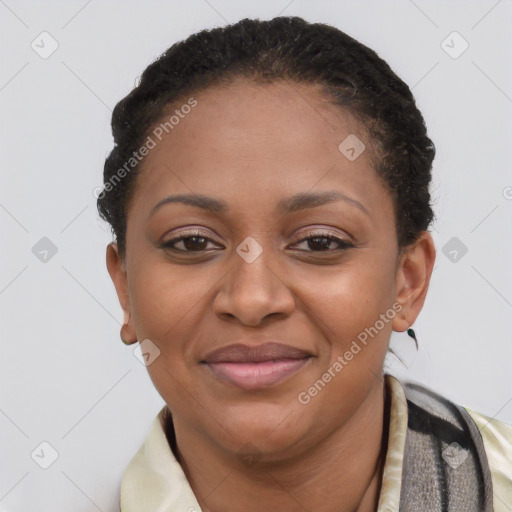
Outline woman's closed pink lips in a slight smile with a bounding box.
[201,342,312,390]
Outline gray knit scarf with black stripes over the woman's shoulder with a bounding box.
[400,383,493,512]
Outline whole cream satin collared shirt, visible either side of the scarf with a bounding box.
[120,375,512,512]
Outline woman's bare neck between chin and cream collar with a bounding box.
[166,379,390,512]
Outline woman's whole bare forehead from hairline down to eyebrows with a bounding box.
[127,80,386,222]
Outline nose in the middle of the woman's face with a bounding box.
[214,251,295,327]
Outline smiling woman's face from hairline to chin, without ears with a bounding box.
[111,81,420,458]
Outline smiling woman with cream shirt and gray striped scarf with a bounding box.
[98,17,512,512]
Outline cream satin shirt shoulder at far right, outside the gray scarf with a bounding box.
[464,407,512,512]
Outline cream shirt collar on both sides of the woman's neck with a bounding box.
[120,374,407,512]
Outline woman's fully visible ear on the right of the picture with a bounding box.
[392,231,436,332]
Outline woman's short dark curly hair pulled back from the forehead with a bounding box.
[97,16,435,258]
